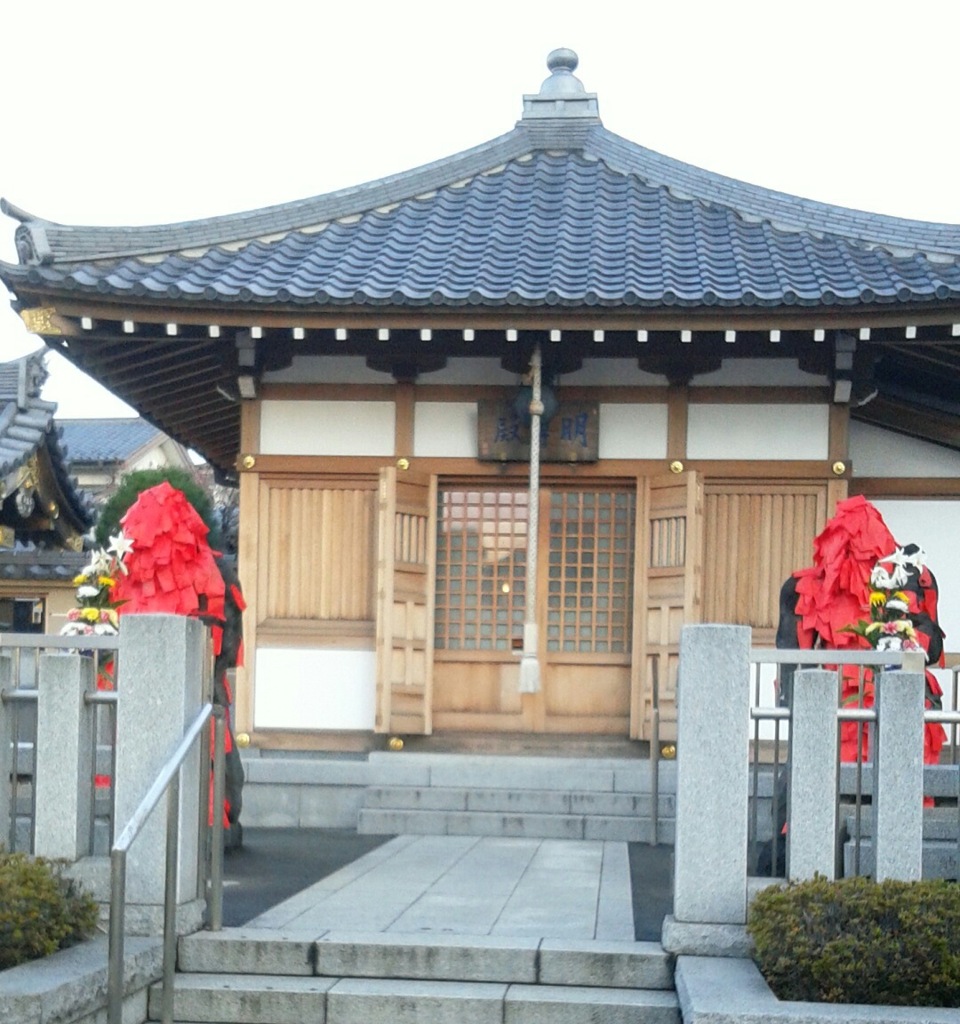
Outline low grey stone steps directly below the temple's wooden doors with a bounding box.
[357,754,675,843]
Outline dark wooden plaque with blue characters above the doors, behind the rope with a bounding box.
[477,399,600,462]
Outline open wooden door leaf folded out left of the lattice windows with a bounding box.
[375,467,437,734]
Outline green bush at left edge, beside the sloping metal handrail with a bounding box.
[0,851,98,970]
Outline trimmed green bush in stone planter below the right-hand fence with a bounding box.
[747,878,960,1007]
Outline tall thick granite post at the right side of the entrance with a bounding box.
[673,626,750,925]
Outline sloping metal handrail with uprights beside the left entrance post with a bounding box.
[106,703,226,1024]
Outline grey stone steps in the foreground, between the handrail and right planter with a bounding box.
[155,928,681,1024]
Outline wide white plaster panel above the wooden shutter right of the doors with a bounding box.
[687,404,830,462]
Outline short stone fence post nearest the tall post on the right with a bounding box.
[787,669,839,882]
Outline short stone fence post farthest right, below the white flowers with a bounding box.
[873,659,923,882]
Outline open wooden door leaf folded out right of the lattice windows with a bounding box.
[630,472,703,739]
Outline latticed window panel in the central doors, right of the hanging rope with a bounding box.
[547,490,637,654]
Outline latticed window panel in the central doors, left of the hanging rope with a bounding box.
[435,490,529,650]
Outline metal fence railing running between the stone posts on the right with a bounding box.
[748,648,960,876]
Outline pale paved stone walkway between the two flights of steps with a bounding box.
[245,836,634,941]
